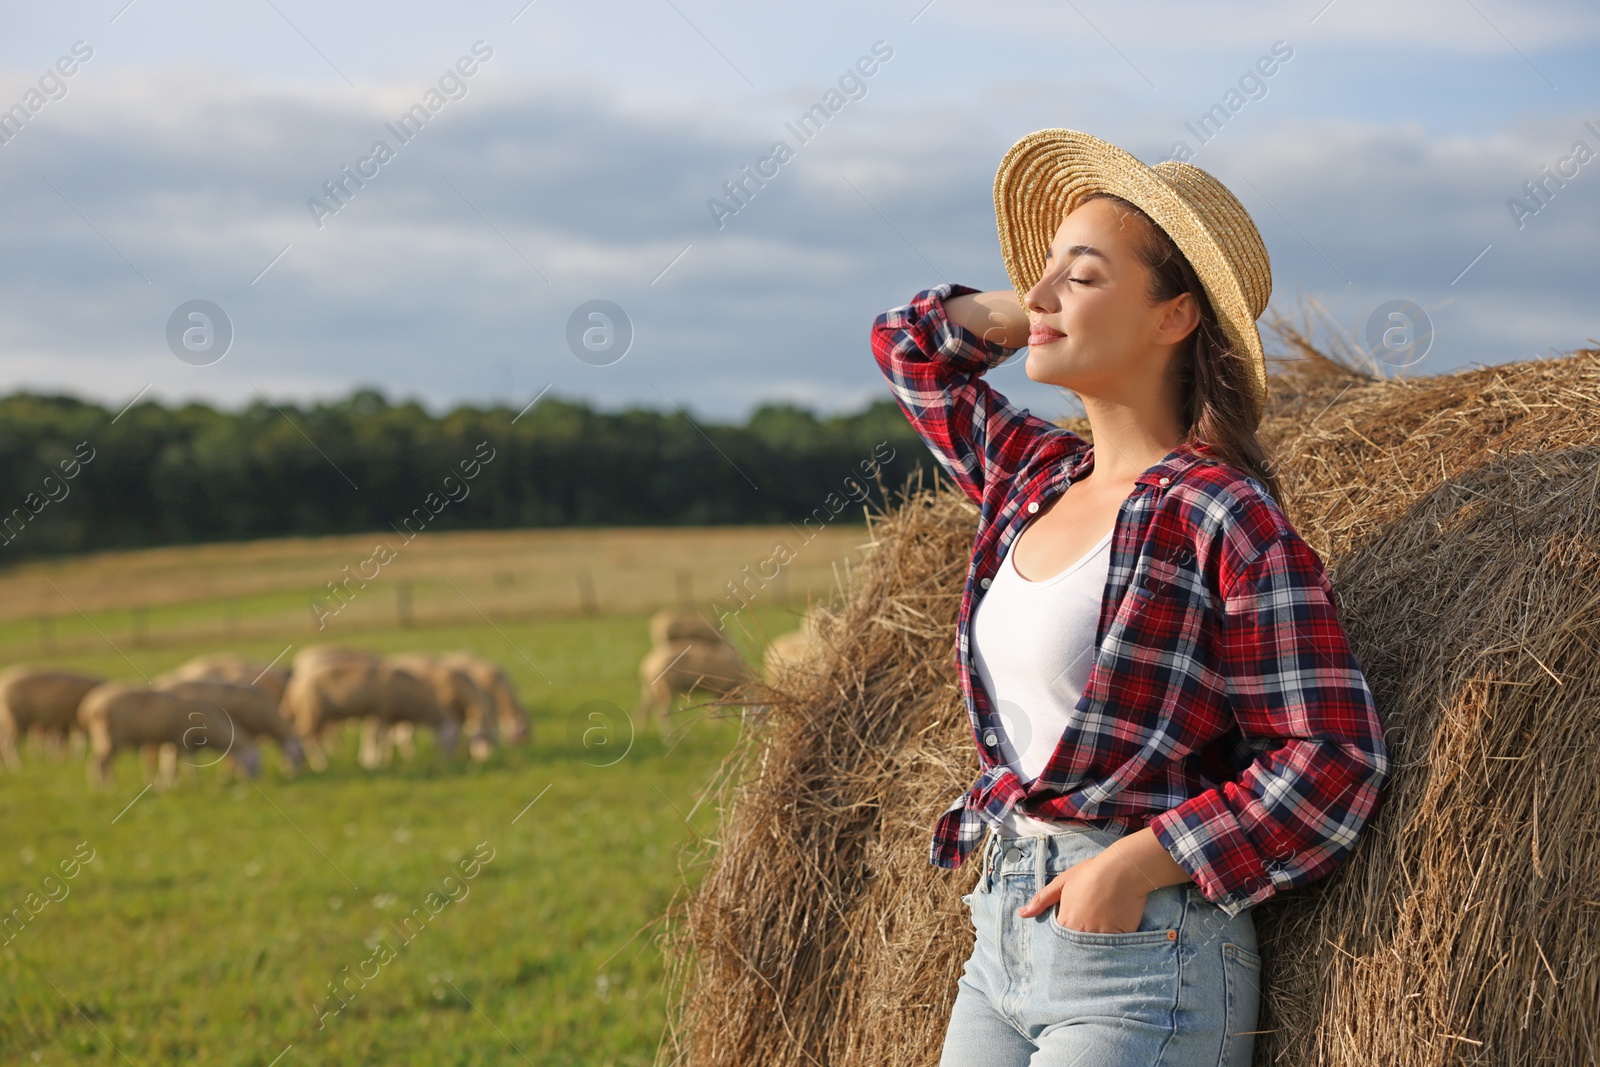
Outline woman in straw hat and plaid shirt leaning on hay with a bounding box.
[872,130,1389,1067]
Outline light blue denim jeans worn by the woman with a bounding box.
[939,825,1261,1067]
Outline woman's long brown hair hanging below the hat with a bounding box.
[1078,192,1283,504]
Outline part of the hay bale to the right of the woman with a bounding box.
[1258,350,1600,1067]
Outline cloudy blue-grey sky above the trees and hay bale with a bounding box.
[0,0,1600,421]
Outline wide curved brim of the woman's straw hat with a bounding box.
[995,130,1270,402]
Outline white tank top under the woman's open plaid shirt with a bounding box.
[971,531,1114,837]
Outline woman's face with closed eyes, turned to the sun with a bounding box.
[1022,200,1200,398]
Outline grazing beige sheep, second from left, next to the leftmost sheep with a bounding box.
[78,681,261,787]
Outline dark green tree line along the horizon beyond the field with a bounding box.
[0,389,936,561]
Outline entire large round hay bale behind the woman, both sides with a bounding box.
[659,350,1600,1067]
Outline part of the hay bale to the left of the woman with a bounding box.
[662,470,976,1067]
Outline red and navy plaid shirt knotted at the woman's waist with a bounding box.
[872,285,1389,915]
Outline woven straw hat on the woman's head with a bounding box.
[995,130,1272,402]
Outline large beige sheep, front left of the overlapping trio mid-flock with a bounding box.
[283,646,461,771]
